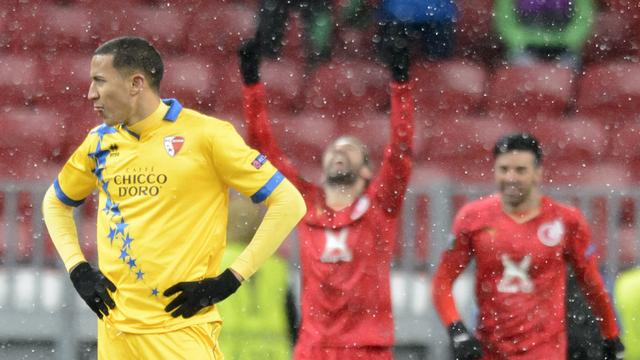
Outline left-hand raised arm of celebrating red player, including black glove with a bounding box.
[238,39,313,195]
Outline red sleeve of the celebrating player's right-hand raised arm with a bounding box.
[369,82,413,216]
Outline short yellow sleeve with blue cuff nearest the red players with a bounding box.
[211,122,284,203]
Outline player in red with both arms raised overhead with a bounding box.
[239,32,413,360]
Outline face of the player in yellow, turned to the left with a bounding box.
[87,55,132,126]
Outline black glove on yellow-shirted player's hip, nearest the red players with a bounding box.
[164,269,240,318]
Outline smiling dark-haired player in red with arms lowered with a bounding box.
[433,134,624,360]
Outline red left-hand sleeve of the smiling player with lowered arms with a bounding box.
[431,208,473,326]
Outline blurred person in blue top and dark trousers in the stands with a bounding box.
[377,0,458,60]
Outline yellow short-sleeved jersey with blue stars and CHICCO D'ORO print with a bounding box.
[53,99,284,333]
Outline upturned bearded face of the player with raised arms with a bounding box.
[323,139,364,185]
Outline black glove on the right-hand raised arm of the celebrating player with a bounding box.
[381,22,409,82]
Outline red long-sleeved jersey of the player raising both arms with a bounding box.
[244,83,413,348]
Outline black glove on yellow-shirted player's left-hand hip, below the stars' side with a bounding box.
[69,262,116,319]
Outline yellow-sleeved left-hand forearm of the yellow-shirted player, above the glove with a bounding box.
[42,187,86,271]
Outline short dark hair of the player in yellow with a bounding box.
[93,36,164,93]
